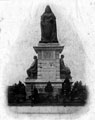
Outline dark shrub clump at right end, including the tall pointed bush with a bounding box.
[61,79,88,104]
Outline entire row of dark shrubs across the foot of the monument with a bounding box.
[8,78,88,106]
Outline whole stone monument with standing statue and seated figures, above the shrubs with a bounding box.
[25,5,71,97]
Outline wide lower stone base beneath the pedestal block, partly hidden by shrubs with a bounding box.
[25,79,64,98]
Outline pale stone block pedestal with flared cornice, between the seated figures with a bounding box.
[34,43,64,82]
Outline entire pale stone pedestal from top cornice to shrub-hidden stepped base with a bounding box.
[25,43,64,96]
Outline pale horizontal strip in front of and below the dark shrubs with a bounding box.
[9,106,84,114]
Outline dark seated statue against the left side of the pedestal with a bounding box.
[27,56,37,79]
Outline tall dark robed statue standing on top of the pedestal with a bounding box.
[40,5,58,43]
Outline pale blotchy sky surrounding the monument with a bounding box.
[0,0,95,85]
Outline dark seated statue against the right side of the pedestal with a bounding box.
[60,55,71,79]
